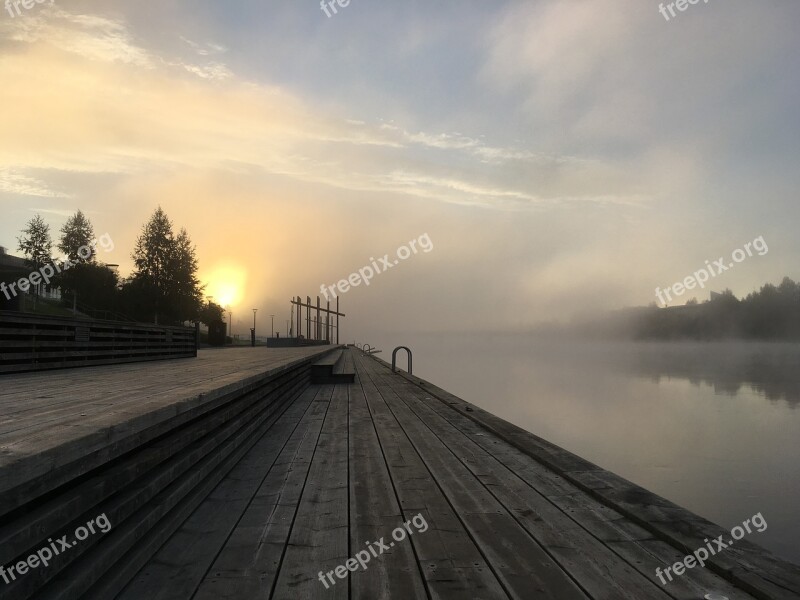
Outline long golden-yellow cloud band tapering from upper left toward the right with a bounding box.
[0,8,631,216]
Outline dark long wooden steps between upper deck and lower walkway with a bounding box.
[0,357,322,600]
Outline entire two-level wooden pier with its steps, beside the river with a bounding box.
[0,346,800,600]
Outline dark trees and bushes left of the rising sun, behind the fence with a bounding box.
[12,207,223,325]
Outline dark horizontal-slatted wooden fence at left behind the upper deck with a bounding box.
[0,311,197,373]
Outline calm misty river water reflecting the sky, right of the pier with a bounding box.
[368,335,800,563]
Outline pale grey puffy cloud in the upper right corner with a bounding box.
[480,0,800,153]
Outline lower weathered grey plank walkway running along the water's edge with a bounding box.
[121,351,792,600]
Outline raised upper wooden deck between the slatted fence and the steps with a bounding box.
[0,347,332,504]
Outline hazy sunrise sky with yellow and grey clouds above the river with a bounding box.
[0,0,800,340]
